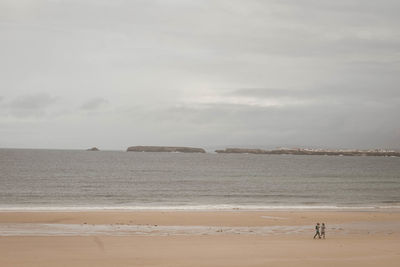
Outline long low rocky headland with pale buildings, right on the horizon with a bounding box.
[215,148,400,157]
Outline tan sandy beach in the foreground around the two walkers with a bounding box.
[0,211,400,267]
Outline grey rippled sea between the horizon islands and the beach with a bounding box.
[0,149,400,210]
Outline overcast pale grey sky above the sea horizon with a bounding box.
[0,0,400,149]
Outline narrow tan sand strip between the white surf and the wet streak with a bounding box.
[0,210,400,227]
